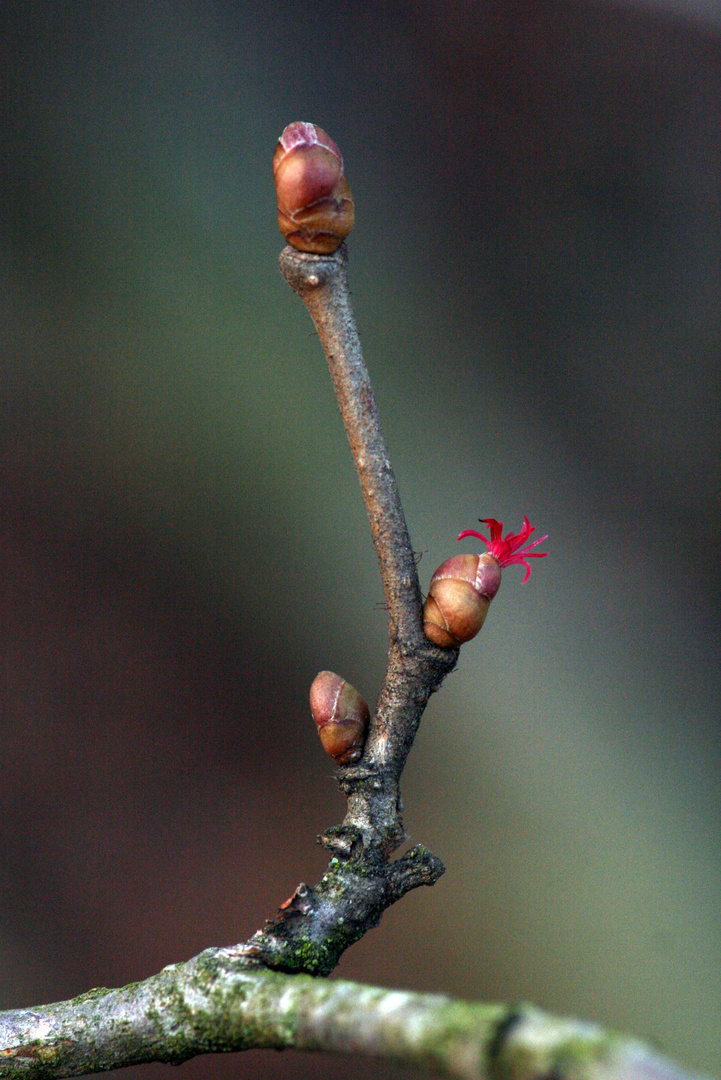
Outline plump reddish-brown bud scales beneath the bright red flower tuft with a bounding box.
[423,553,501,649]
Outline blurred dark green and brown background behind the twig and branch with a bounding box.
[0,0,721,1080]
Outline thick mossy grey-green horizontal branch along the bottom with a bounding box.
[0,947,708,1080]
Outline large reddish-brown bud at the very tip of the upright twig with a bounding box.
[273,120,355,255]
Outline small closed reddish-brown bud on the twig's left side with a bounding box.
[311,672,370,765]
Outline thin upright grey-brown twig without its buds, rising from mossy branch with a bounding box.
[239,244,458,974]
